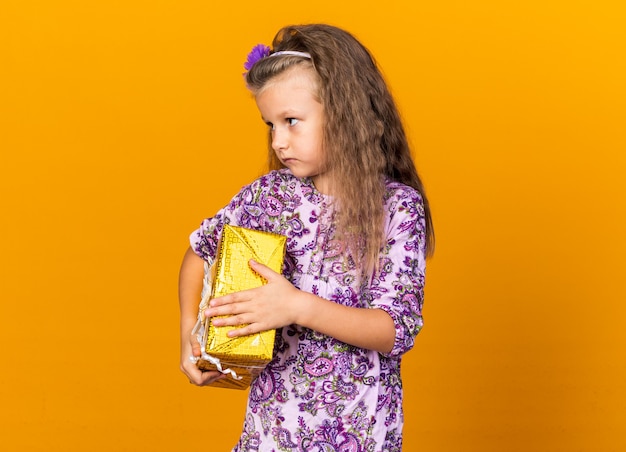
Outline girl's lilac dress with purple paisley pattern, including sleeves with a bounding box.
[190,169,425,452]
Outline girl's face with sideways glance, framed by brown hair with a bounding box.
[256,67,328,193]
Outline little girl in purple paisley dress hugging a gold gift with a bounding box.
[179,25,434,451]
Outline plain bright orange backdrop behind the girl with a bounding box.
[0,0,626,452]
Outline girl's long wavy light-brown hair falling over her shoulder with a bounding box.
[246,24,434,271]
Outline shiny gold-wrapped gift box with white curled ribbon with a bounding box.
[196,225,287,389]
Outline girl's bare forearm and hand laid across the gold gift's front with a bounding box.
[205,261,395,353]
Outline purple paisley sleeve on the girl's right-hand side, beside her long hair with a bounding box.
[368,187,426,357]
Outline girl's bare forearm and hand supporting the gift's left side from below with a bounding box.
[178,248,222,386]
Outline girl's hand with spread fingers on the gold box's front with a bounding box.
[204,260,301,337]
